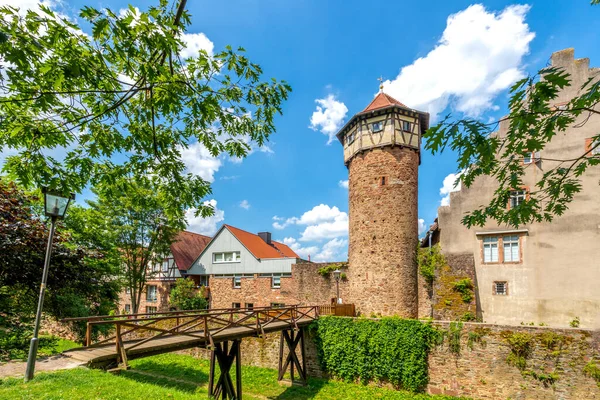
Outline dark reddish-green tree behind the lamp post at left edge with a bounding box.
[0,179,120,350]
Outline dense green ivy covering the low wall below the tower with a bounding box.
[311,316,439,392]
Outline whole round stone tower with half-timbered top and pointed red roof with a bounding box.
[337,91,429,318]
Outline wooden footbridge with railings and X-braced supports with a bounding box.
[63,305,354,399]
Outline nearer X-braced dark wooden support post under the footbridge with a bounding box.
[208,339,242,400]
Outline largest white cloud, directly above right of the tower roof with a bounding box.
[384,4,535,120]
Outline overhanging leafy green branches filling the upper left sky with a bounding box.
[0,0,291,216]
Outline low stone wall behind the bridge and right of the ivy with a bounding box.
[194,321,600,400]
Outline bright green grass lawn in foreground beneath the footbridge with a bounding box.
[0,354,464,400]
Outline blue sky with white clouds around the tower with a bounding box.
[0,0,600,261]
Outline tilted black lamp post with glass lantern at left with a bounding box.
[25,187,75,382]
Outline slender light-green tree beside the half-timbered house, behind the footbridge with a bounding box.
[86,177,179,313]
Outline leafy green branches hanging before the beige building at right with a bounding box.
[424,0,600,227]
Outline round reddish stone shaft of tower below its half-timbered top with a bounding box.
[348,146,419,318]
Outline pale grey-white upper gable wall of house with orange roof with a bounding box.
[187,229,296,275]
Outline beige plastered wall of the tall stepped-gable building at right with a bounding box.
[438,49,600,328]
